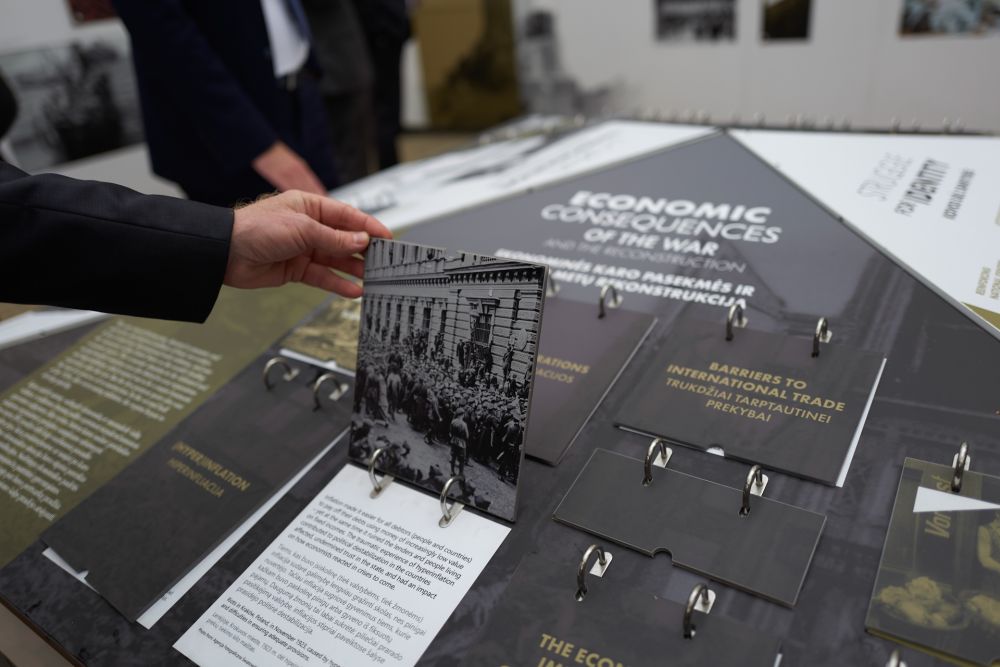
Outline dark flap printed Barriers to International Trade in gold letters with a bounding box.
[616,319,882,484]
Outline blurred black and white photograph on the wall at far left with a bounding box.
[0,36,143,171]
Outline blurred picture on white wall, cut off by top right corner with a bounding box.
[899,0,1000,36]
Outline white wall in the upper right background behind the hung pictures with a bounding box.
[515,0,1000,132]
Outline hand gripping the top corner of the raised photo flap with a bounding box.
[223,190,392,299]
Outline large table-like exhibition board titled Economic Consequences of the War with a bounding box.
[0,121,1000,667]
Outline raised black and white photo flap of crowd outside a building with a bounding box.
[350,239,545,521]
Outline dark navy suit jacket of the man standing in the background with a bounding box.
[114,0,336,203]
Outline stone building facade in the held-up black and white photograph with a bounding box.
[363,242,544,388]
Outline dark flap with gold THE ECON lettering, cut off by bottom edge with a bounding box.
[452,554,781,667]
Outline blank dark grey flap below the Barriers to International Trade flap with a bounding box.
[553,449,826,607]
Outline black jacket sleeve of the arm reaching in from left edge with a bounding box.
[0,162,233,322]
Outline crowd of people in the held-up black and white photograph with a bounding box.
[351,329,527,494]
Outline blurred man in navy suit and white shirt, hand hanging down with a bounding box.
[113,0,338,206]
